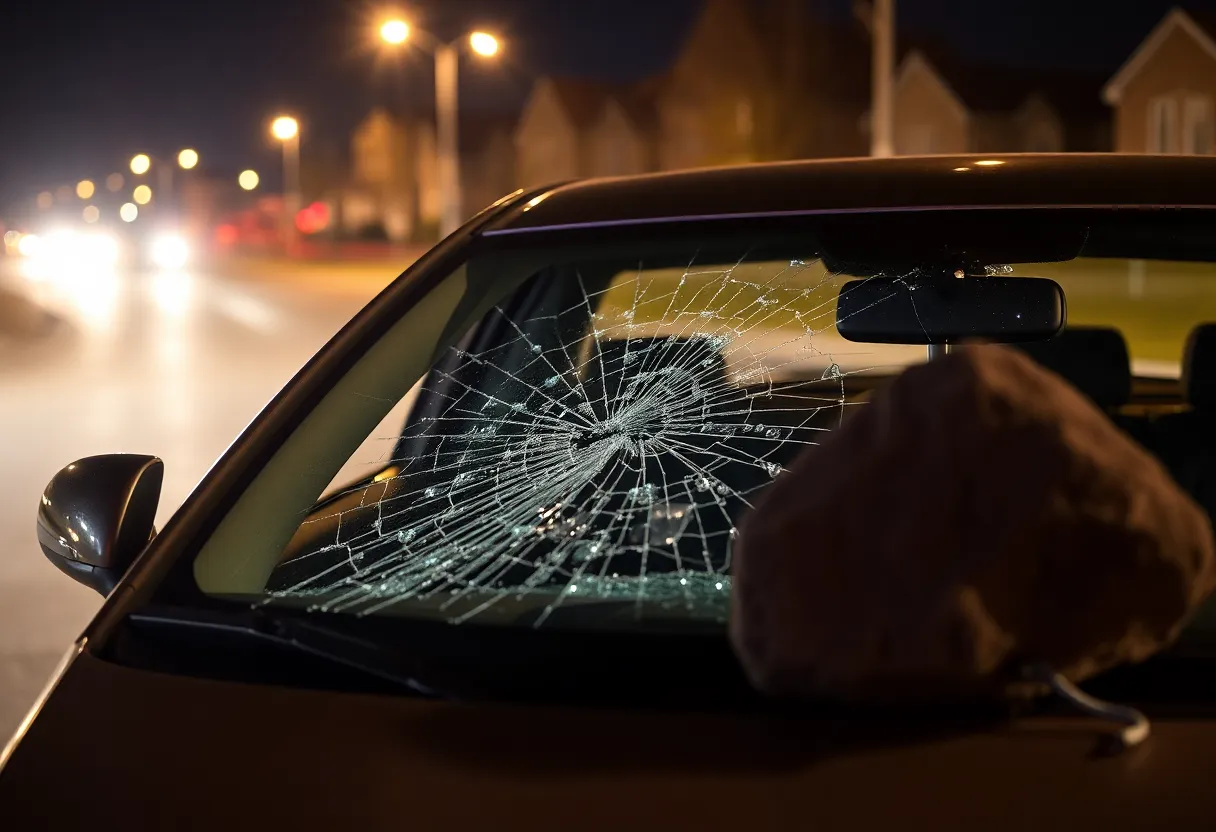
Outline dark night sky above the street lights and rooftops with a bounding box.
[0,0,1216,206]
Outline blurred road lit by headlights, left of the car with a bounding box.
[0,258,400,746]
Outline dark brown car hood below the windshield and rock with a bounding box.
[0,652,1216,831]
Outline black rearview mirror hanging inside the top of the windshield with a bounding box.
[837,277,1068,344]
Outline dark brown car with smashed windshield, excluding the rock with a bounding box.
[0,154,1216,830]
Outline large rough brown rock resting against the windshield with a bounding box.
[731,347,1216,702]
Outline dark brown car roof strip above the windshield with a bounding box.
[483,153,1216,236]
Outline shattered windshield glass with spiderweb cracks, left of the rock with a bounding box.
[266,257,924,626]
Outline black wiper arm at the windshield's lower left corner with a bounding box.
[129,608,445,698]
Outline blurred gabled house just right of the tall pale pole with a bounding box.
[894,47,1108,156]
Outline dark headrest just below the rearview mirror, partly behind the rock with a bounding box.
[1018,326,1132,407]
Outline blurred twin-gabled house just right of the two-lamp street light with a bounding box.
[514,78,655,187]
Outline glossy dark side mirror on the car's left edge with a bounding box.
[38,454,164,595]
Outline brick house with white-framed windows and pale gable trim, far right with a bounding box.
[1102,9,1216,154]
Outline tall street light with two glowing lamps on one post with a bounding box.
[379,18,499,237]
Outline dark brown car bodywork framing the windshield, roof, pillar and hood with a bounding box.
[7,156,1216,830]
